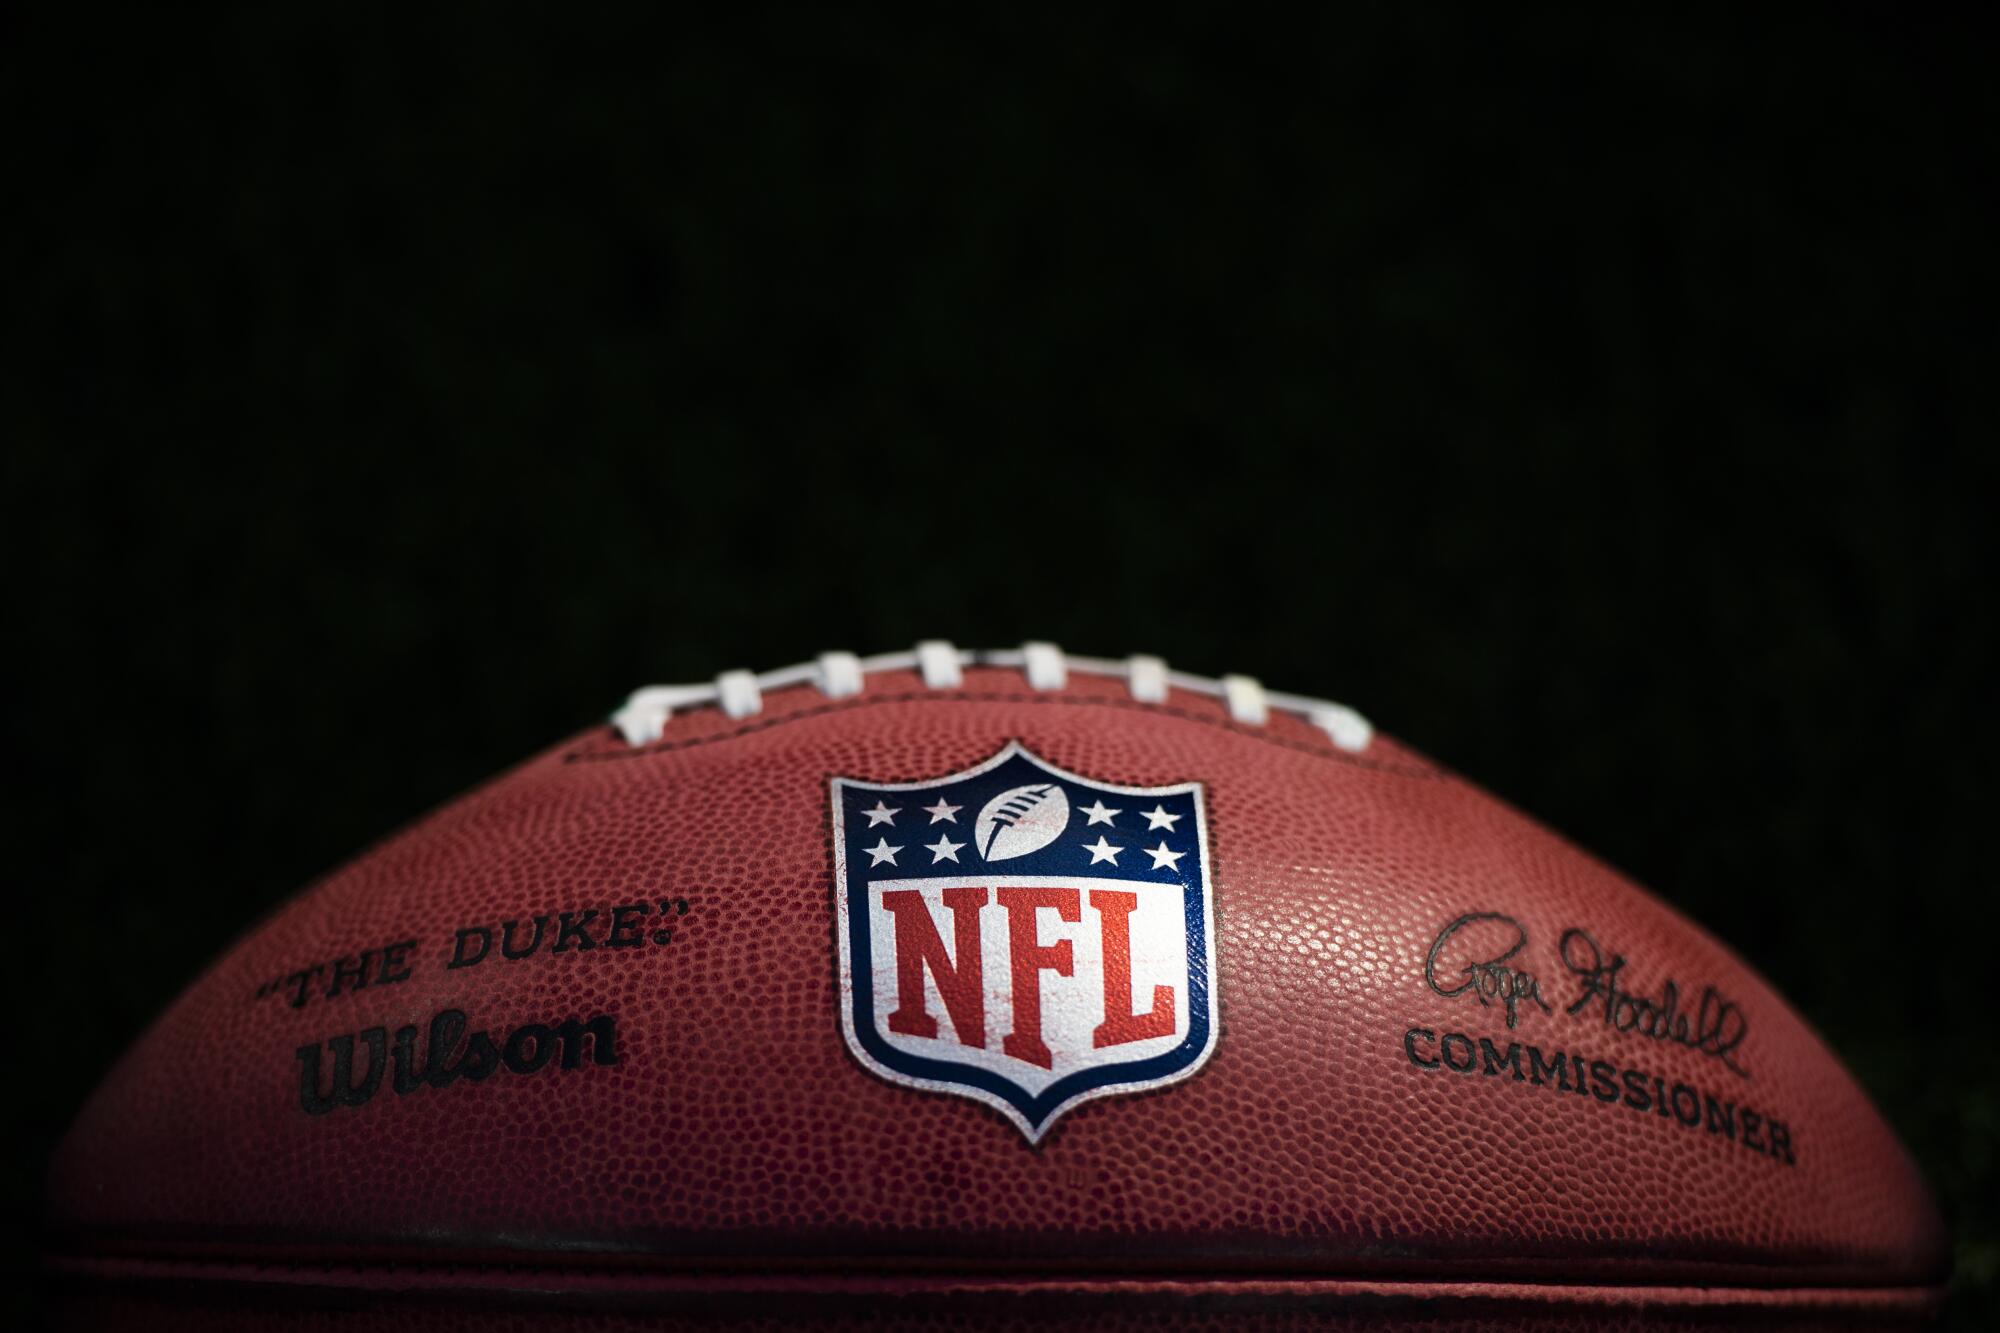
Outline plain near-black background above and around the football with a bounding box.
[0,6,2000,1323]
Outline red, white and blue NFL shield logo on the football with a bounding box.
[834,743,1216,1143]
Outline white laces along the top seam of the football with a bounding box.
[612,638,1374,753]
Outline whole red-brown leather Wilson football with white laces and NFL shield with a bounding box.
[48,642,1946,1327]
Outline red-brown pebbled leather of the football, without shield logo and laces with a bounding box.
[50,669,1946,1327]
